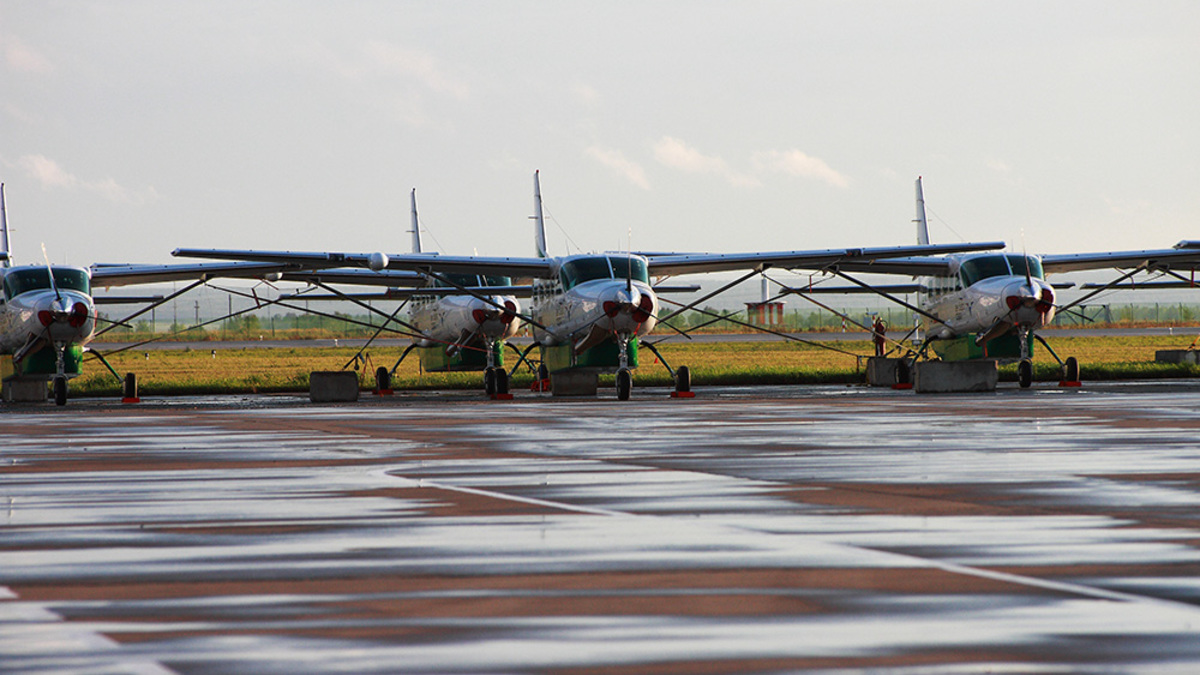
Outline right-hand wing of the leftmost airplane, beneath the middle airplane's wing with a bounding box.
[91,262,426,287]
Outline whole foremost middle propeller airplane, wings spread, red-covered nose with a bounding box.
[173,173,1004,400]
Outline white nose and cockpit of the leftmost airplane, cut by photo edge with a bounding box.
[0,268,96,357]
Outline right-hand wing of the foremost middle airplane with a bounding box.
[647,241,1004,276]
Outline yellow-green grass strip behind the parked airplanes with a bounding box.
[71,335,1200,395]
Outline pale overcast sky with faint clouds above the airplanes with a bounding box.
[0,0,1200,270]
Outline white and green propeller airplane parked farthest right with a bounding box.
[791,177,1200,388]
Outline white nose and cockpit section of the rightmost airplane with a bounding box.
[922,253,1055,339]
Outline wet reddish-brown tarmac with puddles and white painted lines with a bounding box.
[0,381,1200,675]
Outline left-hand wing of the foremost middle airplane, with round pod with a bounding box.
[172,249,552,279]
